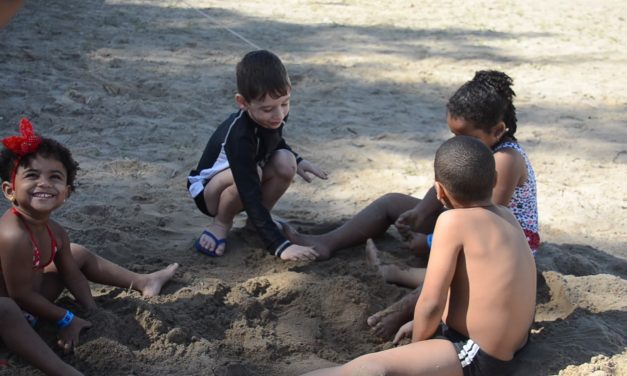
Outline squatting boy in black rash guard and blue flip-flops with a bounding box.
[187,50,327,260]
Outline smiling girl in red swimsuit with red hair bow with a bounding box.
[0,119,178,351]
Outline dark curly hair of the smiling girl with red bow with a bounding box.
[0,137,79,192]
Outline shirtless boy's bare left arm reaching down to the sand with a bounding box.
[412,210,462,342]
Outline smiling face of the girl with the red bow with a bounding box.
[2,155,70,214]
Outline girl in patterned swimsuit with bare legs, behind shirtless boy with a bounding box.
[284,71,540,338]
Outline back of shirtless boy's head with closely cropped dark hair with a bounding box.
[433,136,496,202]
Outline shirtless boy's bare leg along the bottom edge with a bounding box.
[305,339,463,376]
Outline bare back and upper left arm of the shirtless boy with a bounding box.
[432,205,536,360]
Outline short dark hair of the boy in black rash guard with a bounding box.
[236,50,292,102]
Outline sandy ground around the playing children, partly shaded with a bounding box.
[0,0,627,376]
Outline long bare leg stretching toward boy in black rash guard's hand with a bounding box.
[284,193,420,260]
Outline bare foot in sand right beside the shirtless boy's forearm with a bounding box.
[367,286,422,339]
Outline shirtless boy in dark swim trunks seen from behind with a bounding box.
[307,136,536,376]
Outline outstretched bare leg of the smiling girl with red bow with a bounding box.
[70,243,179,297]
